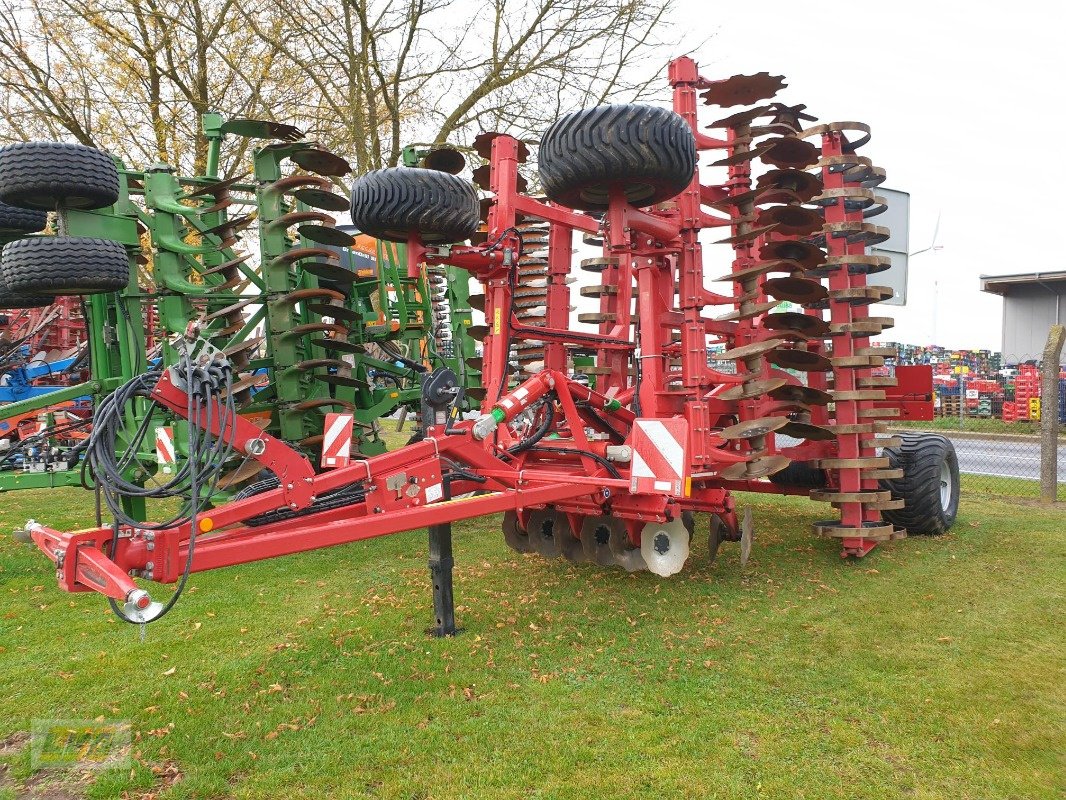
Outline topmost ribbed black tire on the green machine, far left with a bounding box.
[0,142,118,211]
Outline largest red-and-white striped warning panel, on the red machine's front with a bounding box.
[629,418,690,497]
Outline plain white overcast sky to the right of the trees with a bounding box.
[677,0,1066,350]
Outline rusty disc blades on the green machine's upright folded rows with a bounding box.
[168,119,377,489]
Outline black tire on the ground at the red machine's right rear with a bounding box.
[881,433,958,535]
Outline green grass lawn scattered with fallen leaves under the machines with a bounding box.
[0,479,1066,800]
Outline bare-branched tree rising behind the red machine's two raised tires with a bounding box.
[246,0,674,172]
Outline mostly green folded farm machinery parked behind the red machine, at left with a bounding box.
[0,114,477,501]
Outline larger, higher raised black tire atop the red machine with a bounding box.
[537,105,696,210]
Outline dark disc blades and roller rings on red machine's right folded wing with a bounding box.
[705,74,900,538]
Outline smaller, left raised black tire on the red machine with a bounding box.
[352,166,481,244]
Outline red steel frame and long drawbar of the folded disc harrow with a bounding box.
[30,58,908,601]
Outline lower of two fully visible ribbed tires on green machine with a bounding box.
[0,236,130,297]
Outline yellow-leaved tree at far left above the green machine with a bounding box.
[0,0,307,173]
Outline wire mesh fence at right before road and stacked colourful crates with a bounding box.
[887,345,1066,500]
